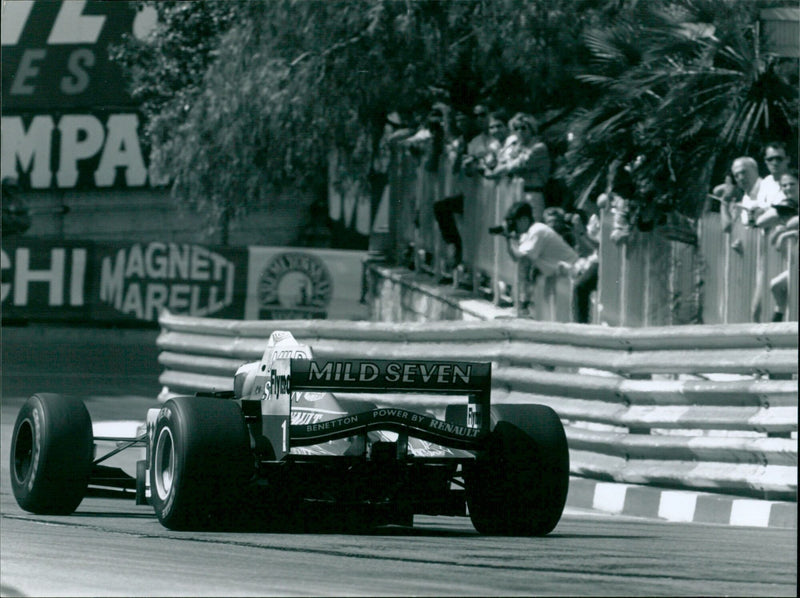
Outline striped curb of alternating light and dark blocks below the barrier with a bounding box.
[567,477,797,529]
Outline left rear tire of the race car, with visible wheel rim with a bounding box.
[150,397,254,530]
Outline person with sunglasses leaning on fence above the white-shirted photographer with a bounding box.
[486,112,550,221]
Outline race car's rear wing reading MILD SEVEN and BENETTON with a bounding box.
[262,359,492,458]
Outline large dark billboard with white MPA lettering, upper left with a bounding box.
[0,0,156,189]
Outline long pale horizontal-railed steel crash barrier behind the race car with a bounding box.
[157,312,798,501]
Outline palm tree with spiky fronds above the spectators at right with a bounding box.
[567,0,798,219]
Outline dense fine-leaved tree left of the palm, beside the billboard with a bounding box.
[109,0,617,234]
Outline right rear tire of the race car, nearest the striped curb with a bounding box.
[464,405,569,536]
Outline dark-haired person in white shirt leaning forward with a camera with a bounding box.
[506,201,578,313]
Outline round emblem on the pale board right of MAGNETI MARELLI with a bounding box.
[258,252,333,320]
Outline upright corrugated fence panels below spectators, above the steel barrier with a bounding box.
[386,150,798,326]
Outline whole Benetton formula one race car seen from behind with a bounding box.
[11,331,569,535]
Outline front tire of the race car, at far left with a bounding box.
[10,393,94,515]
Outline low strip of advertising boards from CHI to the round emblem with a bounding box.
[0,238,369,325]
